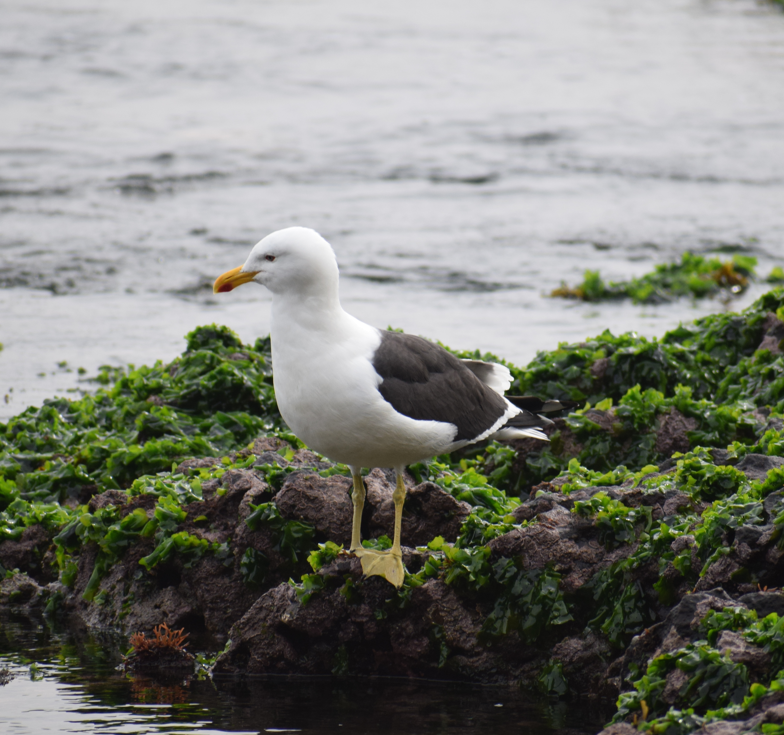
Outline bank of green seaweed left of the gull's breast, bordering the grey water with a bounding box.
[0,325,283,503]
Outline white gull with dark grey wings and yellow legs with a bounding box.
[213,227,568,587]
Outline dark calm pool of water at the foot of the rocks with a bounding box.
[0,618,602,735]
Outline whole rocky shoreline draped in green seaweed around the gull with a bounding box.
[0,289,784,734]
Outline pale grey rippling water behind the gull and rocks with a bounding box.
[0,0,784,418]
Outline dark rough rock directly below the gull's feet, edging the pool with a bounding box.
[214,577,508,680]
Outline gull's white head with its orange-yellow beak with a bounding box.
[212,227,338,294]
